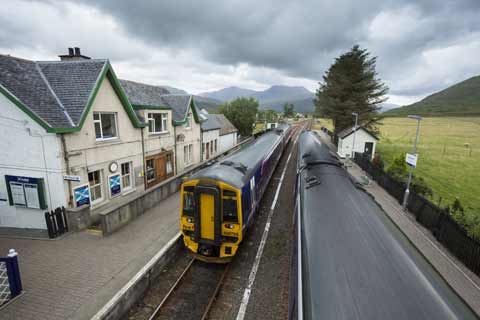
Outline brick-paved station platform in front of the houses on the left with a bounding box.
[0,192,180,320]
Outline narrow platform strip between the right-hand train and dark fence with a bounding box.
[317,131,480,316]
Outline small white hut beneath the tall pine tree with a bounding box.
[337,126,378,159]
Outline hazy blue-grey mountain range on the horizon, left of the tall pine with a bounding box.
[200,85,314,113]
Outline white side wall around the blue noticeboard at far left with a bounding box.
[0,94,66,229]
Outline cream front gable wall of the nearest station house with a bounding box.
[65,78,144,207]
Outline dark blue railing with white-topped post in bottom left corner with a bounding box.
[0,249,22,306]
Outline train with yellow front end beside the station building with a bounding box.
[180,124,292,263]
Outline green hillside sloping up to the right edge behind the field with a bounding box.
[384,76,480,116]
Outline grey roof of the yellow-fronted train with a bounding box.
[188,125,290,188]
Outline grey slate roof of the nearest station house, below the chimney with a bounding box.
[0,55,107,128]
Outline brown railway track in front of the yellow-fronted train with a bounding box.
[149,259,228,320]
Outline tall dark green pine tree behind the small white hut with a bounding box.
[315,45,388,135]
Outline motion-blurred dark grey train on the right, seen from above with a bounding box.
[289,131,477,320]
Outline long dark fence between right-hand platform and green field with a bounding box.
[355,153,480,276]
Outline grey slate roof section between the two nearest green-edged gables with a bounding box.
[120,80,170,107]
